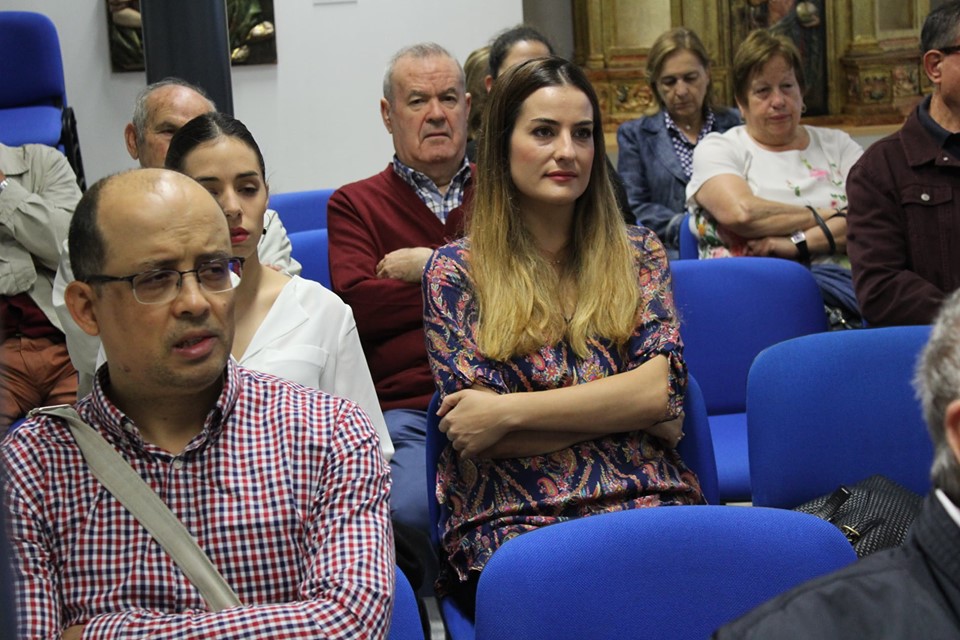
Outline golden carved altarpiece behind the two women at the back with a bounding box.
[573,0,931,132]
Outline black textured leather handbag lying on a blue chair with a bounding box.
[794,475,923,558]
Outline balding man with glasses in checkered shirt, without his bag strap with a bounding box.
[2,169,394,638]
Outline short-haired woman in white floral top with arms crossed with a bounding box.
[687,29,863,320]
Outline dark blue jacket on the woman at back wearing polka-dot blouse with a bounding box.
[617,109,740,250]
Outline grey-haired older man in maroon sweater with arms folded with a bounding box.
[327,43,473,531]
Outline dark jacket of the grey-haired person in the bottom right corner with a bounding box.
[713,494,960,640]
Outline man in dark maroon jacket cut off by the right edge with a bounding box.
[847,0,960,326]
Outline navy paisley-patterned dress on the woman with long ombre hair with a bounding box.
[424,227,703,595]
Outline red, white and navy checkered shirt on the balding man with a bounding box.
[0,360,394,639]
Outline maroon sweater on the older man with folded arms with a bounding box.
[327,165,473,411]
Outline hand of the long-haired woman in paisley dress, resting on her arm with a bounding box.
[437,389,508,458]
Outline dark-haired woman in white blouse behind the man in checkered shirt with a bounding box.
[166,112,393,460]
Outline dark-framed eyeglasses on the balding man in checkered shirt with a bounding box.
[84,257,244,304]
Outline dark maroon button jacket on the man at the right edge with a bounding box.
[847,107,960,326]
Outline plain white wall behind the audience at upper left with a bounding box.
[0,0,523,193]
